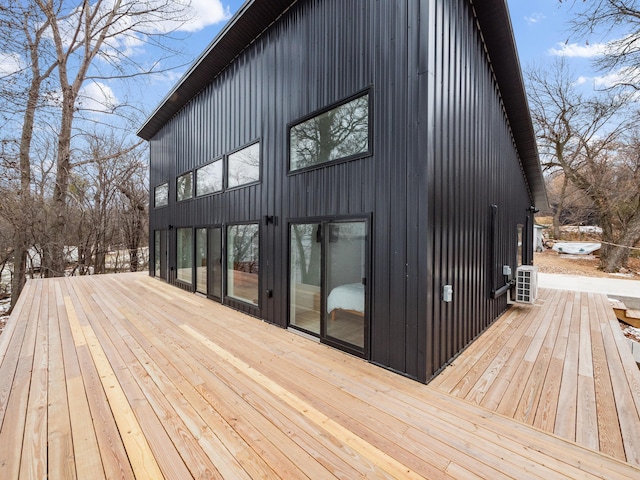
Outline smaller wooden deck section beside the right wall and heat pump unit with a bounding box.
[430,290,640,465]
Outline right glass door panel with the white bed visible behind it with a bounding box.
[325,221,367,348]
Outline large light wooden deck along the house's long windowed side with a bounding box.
[0,274,640,480]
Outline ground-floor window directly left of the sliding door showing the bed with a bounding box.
[227,224,260,305]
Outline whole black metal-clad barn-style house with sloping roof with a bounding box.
[138,0,547,382]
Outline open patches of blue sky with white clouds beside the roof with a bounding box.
[0,0,622,129]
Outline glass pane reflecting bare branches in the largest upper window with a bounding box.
[289,95,369,170]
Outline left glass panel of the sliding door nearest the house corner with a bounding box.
[289,223,322,335]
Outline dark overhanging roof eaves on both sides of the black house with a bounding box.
[137,0,548,208]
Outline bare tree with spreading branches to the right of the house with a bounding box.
[528,61,640,271]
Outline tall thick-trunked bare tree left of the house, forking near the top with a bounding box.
[35,0,184,276]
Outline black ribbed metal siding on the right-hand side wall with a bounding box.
[416,0,530,379]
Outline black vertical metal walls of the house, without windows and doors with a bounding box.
[142,0,535,381]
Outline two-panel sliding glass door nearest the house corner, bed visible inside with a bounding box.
[289,220,368,355]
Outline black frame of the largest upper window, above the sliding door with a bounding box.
[286,86,374,175]
